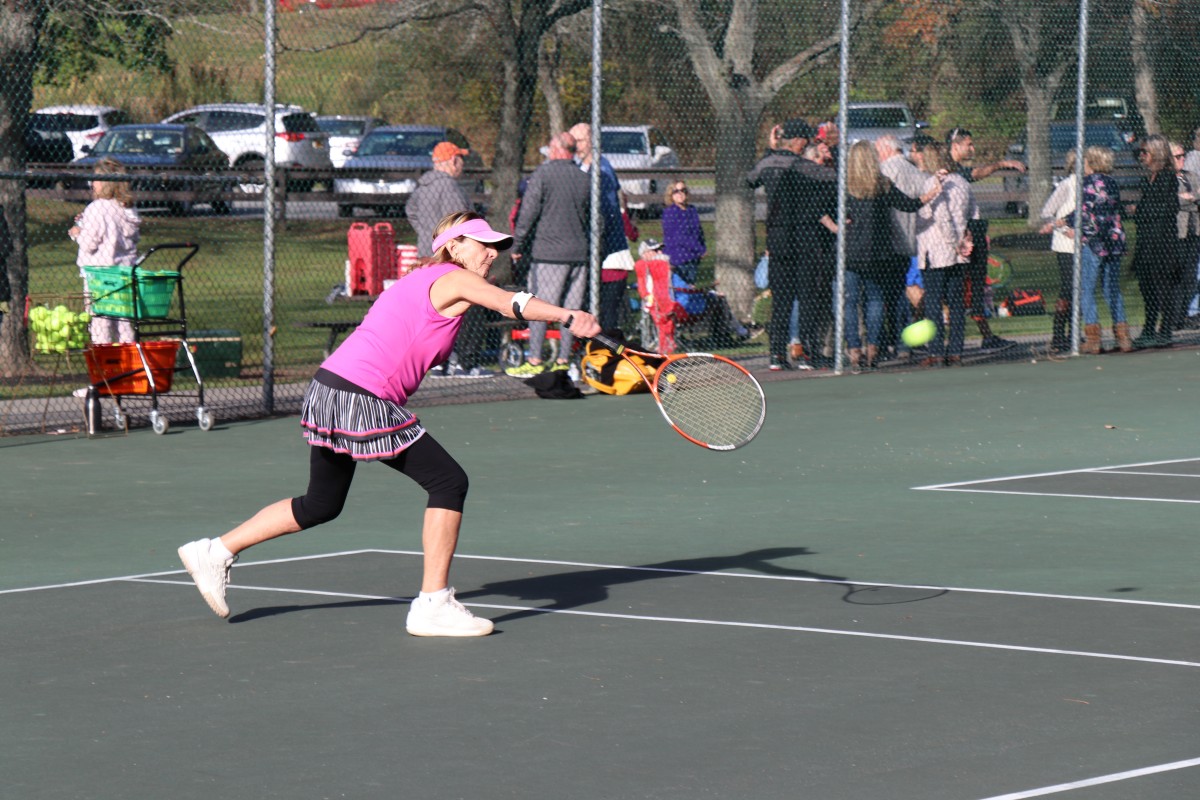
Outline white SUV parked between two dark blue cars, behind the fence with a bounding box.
[163,103,334,192]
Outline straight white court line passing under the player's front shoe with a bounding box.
[131,579,1200,668]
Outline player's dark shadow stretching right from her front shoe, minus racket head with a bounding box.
[458,547,846,624]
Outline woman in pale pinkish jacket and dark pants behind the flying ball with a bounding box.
[917,143,979,367]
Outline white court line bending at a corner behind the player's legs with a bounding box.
[7,548,1200,610]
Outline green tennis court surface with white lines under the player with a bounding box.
[0,349,1200,800]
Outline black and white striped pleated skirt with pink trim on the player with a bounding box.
[300,380,425,461]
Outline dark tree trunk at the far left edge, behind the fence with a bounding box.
[0,1,46,377]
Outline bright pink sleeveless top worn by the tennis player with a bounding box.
[320,264,462,405]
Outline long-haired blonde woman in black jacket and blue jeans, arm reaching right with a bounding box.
[834,139,941,372]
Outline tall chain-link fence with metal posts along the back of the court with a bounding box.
[0,0,1200,434]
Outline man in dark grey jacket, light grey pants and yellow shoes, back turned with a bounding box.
[505,132,592,378]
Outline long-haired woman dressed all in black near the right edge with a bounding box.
[1132,134,1182,350]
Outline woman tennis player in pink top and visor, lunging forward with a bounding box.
[179,212,600,636]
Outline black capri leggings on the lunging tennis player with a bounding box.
[292,433,468,530]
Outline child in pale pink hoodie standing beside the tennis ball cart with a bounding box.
[67,158,142,344]
